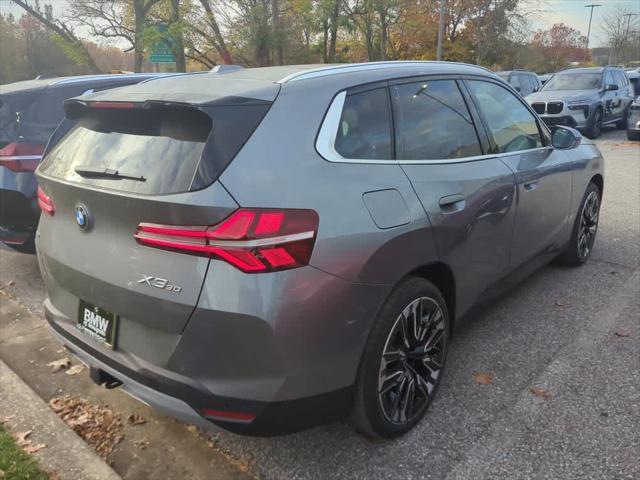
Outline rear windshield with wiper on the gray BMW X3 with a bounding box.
[40,105,266,194]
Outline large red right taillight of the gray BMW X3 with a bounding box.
[134,208,318,273]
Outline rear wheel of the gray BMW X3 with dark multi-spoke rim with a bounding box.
[351,277,450,439]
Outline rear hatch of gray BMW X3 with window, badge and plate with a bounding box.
[37,82,270,347]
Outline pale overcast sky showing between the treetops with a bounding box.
[0,0,640,47]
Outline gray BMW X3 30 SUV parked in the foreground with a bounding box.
[36,62,603,438]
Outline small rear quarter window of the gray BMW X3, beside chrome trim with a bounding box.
[335,88,392,160]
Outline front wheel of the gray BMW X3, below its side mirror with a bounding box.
[558,183,602,267]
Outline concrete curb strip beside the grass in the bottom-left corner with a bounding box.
[0,359,122,480]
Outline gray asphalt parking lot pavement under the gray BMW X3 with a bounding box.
[0,129,640,479]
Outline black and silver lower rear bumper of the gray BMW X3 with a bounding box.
[45,299,354,436]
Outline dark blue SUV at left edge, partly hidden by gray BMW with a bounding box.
[0,74,162,253]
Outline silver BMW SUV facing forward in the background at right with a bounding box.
[527,67,634,138]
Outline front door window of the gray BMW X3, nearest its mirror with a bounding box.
[468,80,543,153]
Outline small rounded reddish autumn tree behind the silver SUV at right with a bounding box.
[532,23,586,72]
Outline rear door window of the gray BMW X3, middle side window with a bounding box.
[391,80,482,160]
